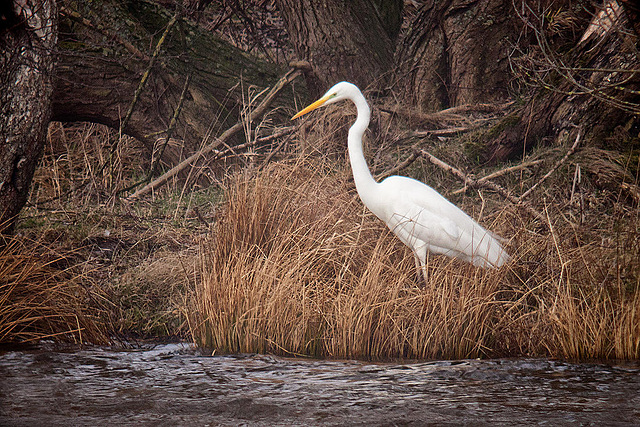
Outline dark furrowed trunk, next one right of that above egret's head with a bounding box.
[396,0,523,111]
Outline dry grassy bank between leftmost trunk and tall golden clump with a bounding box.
[8,123,208,342]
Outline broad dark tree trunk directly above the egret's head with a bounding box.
[276,0,402,96]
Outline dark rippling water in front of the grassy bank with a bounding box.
[0,344,640,426]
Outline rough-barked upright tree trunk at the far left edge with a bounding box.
[0,0,57,233]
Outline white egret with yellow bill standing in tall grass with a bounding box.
[291,82,509,274]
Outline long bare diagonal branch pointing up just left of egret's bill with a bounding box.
[128,68,302,200]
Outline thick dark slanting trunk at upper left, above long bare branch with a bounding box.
[53,1,284,165]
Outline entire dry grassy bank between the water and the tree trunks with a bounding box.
[0,101,640,359]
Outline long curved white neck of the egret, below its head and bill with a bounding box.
[347,93,377,199]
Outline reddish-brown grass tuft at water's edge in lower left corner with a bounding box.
[0,234,107,343]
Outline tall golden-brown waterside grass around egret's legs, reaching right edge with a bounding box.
[189,154,640,359]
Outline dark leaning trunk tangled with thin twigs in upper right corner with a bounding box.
[486,3,640,161]
